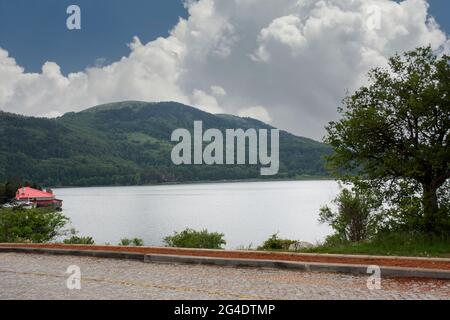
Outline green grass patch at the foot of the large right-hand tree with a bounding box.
[302,234,450,258]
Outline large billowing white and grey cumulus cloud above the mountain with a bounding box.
[0,0,450,139]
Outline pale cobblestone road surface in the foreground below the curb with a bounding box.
[0,253,450,299]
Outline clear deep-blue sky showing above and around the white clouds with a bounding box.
[0,0,450,74]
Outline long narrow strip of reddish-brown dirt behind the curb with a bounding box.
[0,244,450,270]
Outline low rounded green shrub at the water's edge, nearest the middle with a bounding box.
[164,228,226,249]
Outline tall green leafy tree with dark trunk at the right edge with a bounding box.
[326,47,450,233]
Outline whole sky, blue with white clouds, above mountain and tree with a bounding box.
[0,0,450,140]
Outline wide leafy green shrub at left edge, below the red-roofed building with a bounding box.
[0,208,69,243]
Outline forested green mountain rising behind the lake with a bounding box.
[0,101,330,186]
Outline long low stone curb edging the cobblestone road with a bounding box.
[0,247,450,280]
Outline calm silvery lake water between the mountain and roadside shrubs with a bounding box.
[54,181,339,249]
